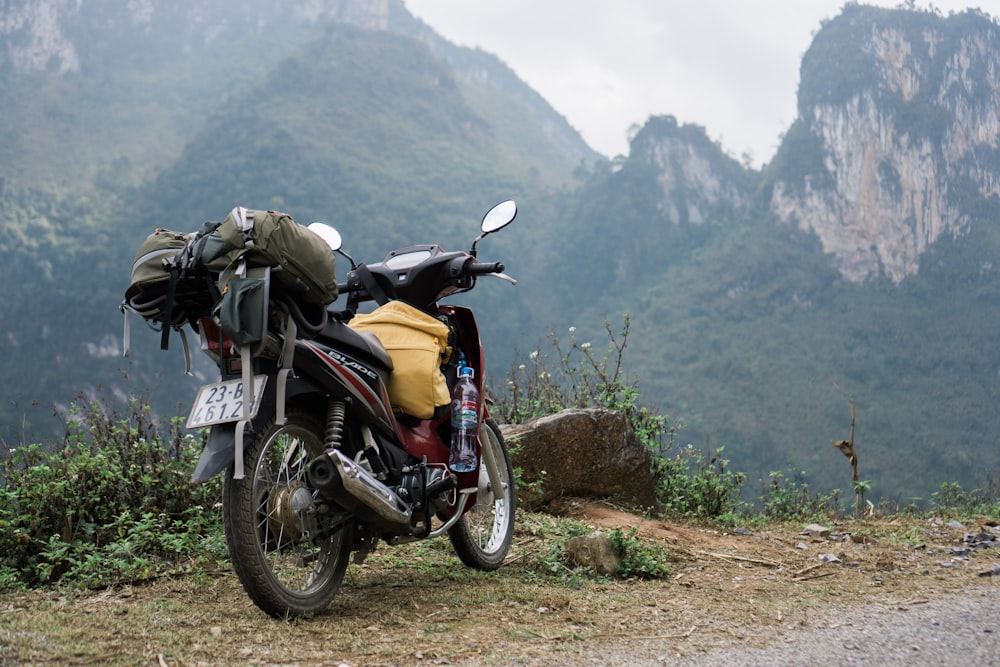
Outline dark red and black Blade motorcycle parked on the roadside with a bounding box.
[188,200,517,618]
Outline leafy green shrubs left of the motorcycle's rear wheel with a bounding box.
[0,397,225,588]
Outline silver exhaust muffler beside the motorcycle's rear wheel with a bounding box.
[307,449,412,526]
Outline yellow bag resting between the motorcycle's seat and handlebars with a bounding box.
[349,301,451,419]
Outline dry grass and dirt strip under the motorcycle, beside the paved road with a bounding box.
[0,500,1000,667]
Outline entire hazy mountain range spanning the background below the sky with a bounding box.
[0,0,1000,502]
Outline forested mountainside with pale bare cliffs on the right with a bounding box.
[573,5,1000,504]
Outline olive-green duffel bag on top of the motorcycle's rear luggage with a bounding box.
[193,206,337,305]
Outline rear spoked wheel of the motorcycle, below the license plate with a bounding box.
[223,412,351,617]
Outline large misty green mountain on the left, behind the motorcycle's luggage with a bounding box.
[0,0,599,442]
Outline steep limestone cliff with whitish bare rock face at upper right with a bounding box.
[767,5,1000,283]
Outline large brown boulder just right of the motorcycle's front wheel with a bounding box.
[502,409,660,510]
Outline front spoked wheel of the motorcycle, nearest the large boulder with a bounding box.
[448,419,517,570]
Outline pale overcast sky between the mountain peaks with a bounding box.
[404,0,980,166]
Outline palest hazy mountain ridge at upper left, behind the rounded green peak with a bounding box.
[0,0,598,192]
